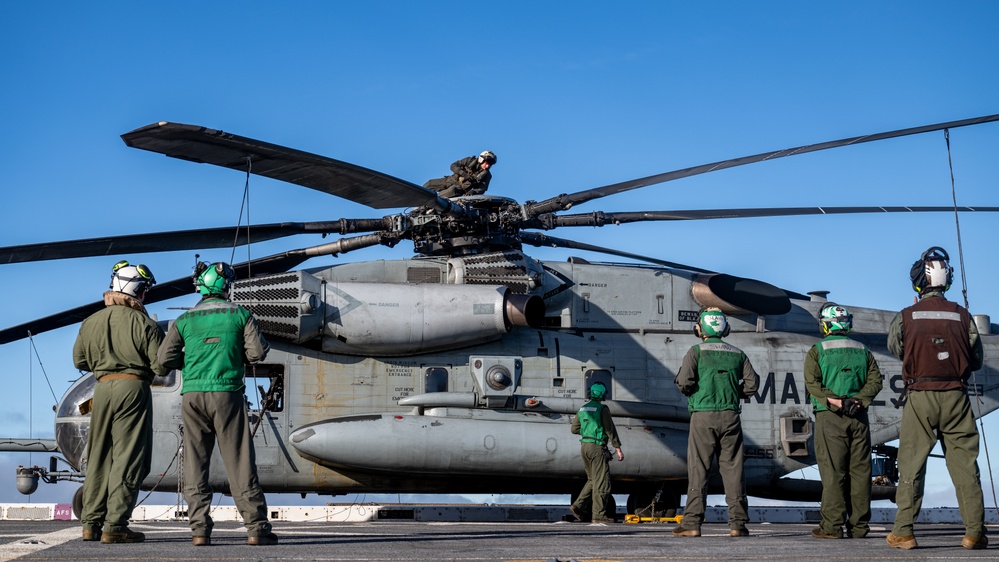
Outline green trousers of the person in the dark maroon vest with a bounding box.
[892,389,985,538]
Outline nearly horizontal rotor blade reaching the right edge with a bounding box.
[544,207,999,228]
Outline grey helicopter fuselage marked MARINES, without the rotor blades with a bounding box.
[57,251,999,497]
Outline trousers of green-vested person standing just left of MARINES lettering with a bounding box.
[681,410,749,529]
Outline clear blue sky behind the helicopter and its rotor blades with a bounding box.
[0,1,999,505]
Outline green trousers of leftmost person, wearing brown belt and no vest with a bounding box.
[80,379,153,533]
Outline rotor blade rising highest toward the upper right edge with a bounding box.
[525,114,999,217]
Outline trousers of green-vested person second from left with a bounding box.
[181,392,271,537]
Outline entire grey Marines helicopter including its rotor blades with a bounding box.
[0,115,999,513]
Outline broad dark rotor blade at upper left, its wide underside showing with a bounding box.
[121,121,437,209]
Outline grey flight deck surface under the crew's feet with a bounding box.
[0,521,999,562]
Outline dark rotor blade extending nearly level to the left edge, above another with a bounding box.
[0,218,392,263]
